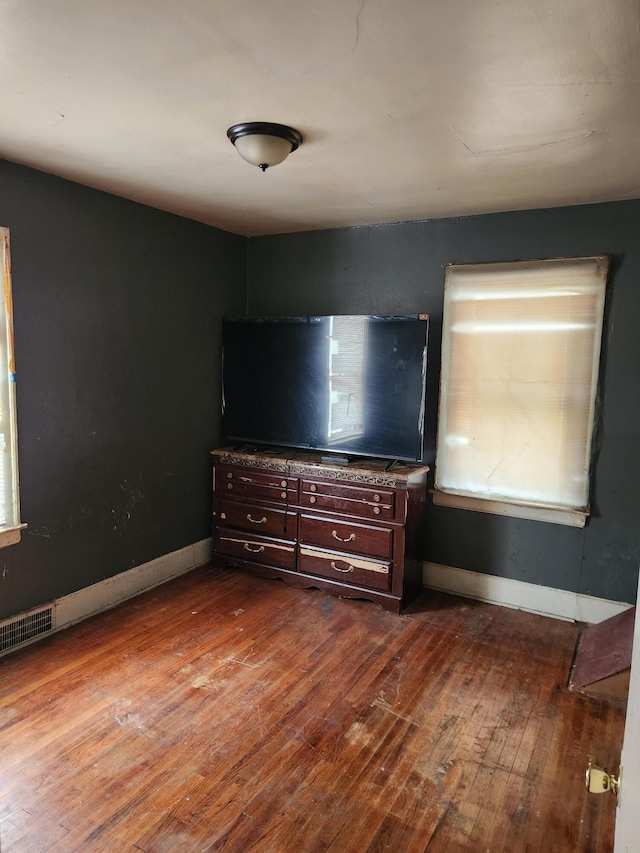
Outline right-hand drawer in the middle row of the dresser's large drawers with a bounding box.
[299,515,393,558]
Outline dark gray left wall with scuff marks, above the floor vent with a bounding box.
[0,162,246,617]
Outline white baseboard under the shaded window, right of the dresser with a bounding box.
[422,563,632,625]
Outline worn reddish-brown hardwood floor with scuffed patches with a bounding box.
[0,568,624,853]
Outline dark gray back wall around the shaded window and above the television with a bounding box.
[248,201,640,602]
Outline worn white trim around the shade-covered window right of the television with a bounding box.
[432,256,609,527]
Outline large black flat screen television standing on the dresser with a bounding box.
[222,314,428,461]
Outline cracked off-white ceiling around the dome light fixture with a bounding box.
[0,0,640,235]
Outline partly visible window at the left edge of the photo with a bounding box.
[0,228,25,546]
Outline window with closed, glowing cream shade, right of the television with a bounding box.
[434,257,609,527]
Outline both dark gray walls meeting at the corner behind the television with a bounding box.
[0,156,640,618]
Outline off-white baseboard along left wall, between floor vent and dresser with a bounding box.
[53,538,211,631]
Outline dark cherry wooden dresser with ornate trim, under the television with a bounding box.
[212,448,429,613]
